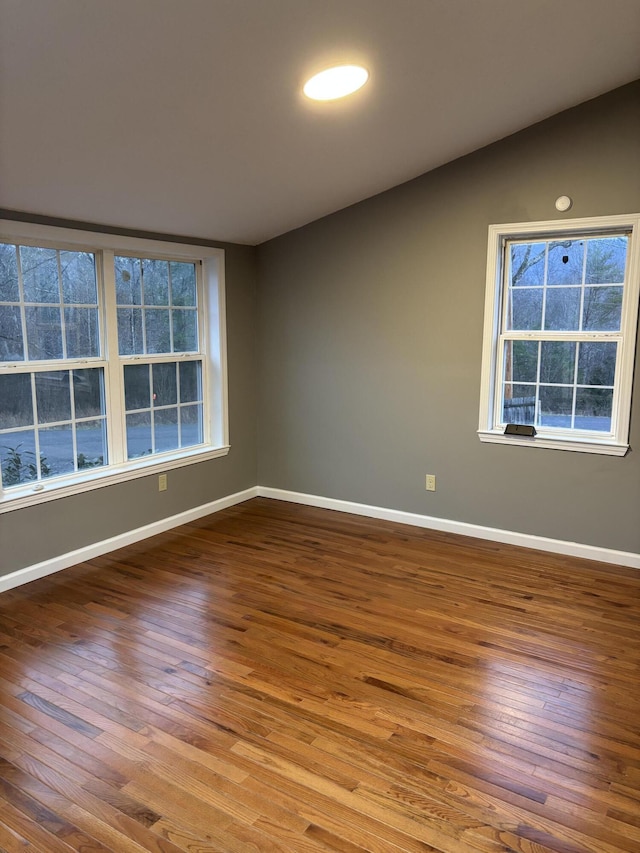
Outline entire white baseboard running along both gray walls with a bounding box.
[0,486,640,593]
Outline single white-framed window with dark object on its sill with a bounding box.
[479,216,640,456]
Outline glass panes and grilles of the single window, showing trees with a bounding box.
[502,234,628,432]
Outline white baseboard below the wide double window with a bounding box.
[0,486,258,593]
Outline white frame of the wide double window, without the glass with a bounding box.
[0,220,230,513]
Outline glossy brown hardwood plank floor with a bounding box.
[0,499,640,853]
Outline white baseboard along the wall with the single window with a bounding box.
[258,486,640,569]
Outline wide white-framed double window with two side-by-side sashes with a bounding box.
[0,222,228,511]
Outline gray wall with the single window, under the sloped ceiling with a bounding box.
[258,83,640,552]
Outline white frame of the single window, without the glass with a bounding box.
[478,214,640,456]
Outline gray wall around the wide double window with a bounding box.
[0,231,257,575]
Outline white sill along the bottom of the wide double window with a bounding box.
[0,445,229,513]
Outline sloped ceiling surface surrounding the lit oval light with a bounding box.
[0,0,640,244]
